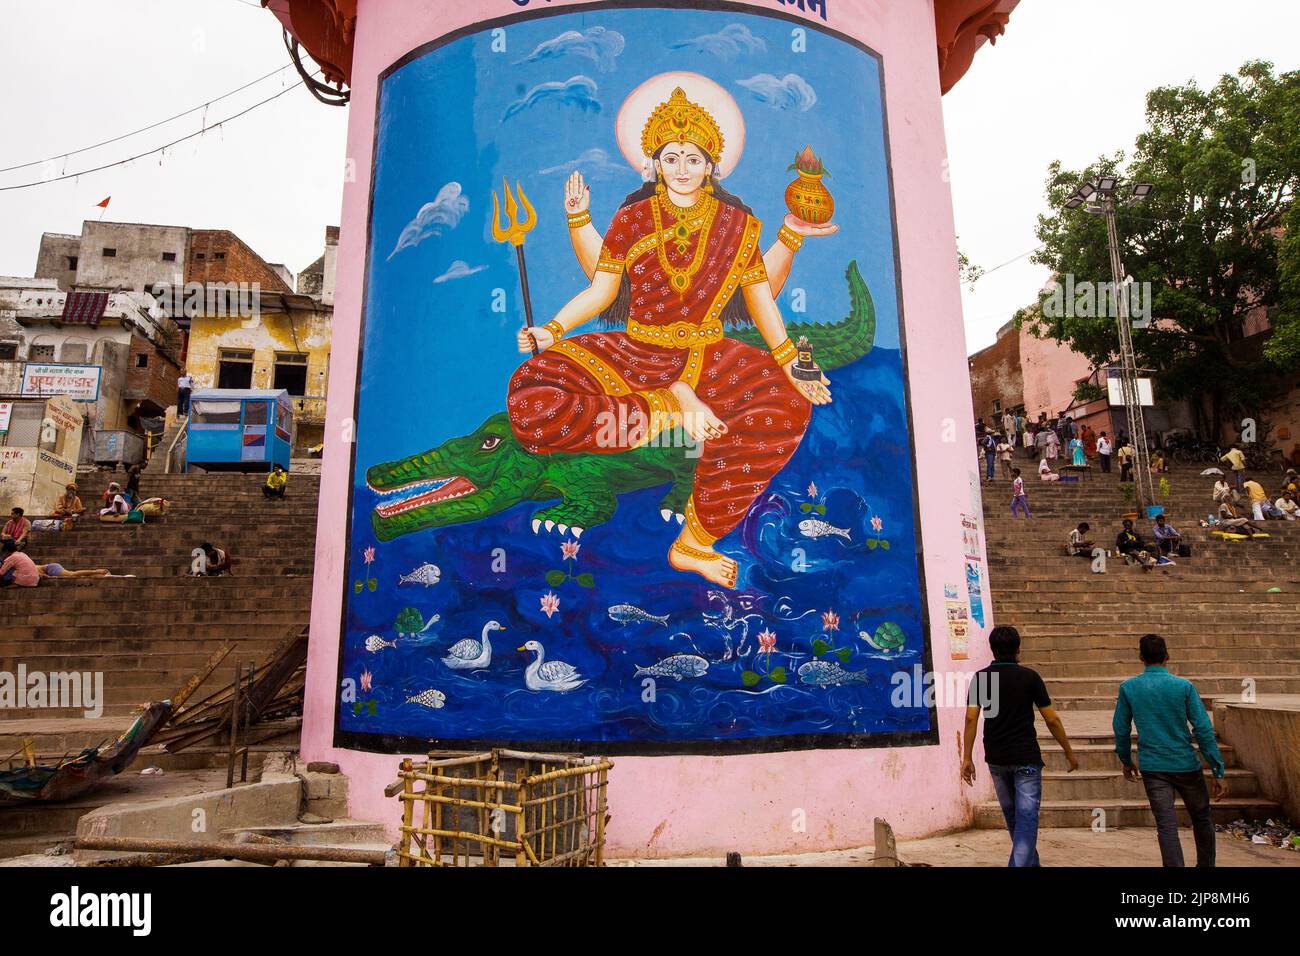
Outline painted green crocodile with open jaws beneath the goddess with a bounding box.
[365,261,876,541]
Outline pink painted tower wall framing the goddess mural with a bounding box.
[302,0,992,856]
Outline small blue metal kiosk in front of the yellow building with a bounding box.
[185,389,294,471]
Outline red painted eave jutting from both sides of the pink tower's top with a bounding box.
[269,0,1019,92]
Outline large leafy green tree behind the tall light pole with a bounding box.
[1017,61,1300,436]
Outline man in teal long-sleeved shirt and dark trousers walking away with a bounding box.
[1113,633,1227,866]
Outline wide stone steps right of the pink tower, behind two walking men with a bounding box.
[976,459,1300,829]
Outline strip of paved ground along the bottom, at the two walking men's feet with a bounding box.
[610,827,1300,866]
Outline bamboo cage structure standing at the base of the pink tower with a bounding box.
[387,749,614,866]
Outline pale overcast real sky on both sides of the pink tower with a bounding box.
[0,0,1300,351]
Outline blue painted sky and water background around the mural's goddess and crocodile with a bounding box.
[339,9,930,749]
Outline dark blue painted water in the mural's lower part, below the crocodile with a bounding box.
[339,349,930,743]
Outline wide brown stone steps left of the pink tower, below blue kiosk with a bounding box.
[0,472,320,856]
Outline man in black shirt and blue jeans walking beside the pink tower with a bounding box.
[962,624,1079,866]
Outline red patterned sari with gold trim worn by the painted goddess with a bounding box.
[507,195,813,542]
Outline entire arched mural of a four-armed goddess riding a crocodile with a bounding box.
[337,7,935,753]
